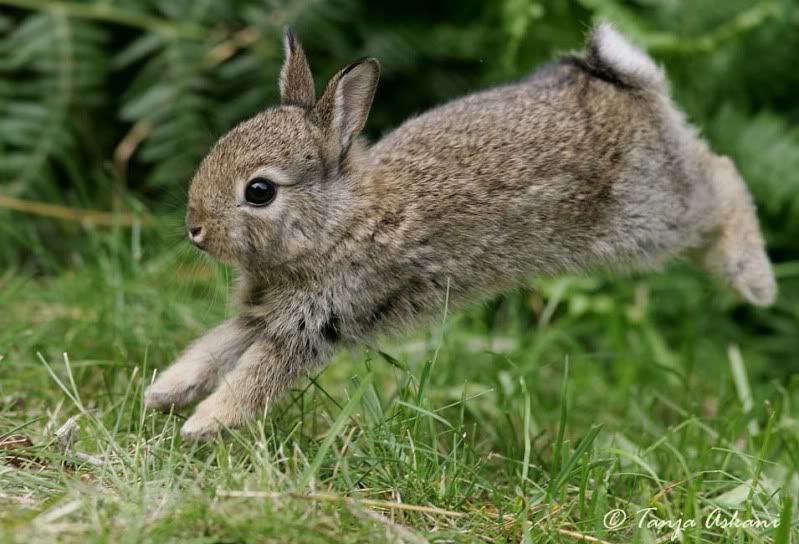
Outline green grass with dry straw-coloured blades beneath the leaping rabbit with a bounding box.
[0,219,799,544]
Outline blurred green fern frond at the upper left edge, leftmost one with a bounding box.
[0,11,106,195]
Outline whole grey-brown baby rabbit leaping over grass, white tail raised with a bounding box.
[145,24,776,438]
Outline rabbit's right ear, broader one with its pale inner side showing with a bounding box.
[314,57,380,154]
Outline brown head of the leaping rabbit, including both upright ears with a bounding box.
[186,30,380,270]
